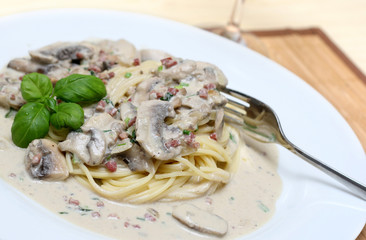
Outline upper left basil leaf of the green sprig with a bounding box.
[20,73,53,102]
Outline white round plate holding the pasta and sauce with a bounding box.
[0,9,366,240]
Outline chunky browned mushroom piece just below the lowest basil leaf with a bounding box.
[25,139,69,180]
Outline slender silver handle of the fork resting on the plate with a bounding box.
[285,143,366,200]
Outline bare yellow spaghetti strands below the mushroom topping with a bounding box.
[67,126,239,204]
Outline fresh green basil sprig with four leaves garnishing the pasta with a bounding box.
[11,73,107,148]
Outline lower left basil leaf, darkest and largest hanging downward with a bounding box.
[11,102,50,148]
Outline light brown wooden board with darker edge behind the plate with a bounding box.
[243,28,366,240]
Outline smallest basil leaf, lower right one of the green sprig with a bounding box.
[51,102,84,130]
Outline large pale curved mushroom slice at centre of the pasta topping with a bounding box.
[136,100,182,160]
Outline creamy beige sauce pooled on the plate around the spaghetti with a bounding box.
[0,108,282,240]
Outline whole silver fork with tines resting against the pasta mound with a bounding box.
[219,88,366,200]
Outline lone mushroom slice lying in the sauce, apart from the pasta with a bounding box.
[172,203,228,237]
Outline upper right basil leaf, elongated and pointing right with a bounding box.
[54,74,107,103]
